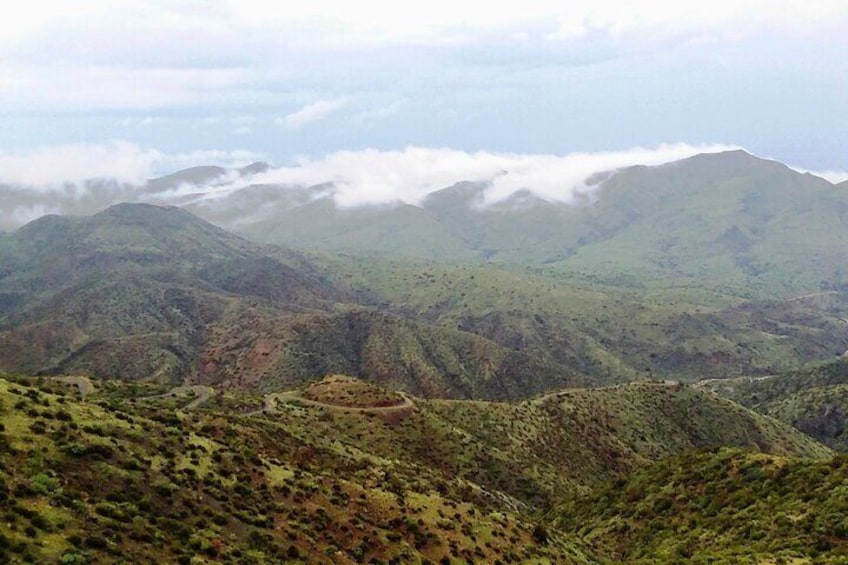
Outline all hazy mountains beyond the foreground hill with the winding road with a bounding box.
[0,151,848,390]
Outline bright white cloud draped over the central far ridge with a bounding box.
[243,144,738,208]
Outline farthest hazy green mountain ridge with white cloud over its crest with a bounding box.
[172,151,848,297]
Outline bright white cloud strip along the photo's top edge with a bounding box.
[0,0,846,56]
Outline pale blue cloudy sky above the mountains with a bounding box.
[0,0,848,192]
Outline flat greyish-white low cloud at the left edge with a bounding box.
[0,141,259,187]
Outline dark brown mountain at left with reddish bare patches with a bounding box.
[0,204,586,398]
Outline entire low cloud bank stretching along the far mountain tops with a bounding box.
[13,141,848,229]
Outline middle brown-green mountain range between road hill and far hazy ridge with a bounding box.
[6,204,848,392]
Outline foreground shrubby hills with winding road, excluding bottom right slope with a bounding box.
[0,376,842,563]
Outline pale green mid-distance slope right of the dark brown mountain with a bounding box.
[314,255,848,383]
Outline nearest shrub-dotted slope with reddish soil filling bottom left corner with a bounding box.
[0,374,587,563]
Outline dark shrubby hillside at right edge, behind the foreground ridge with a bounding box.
[698,358,848,452]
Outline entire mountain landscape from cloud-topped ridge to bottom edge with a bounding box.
[0,151,848,563]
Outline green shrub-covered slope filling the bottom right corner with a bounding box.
[554,450,848,564]
